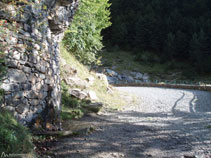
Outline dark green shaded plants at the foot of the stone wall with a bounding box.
[0,109,33,154]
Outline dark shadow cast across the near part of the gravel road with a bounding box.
[45,88,211,158]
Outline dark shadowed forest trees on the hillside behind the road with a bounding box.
[104,0,211,74]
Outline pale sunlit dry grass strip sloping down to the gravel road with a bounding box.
[61,45,126,114]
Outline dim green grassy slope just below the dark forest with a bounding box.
[101,50,211,81]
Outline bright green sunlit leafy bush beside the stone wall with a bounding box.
[63,0,111,65]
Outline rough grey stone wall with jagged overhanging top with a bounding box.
[0,0,78,124]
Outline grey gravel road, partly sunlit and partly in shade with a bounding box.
[48,87,211,158]
